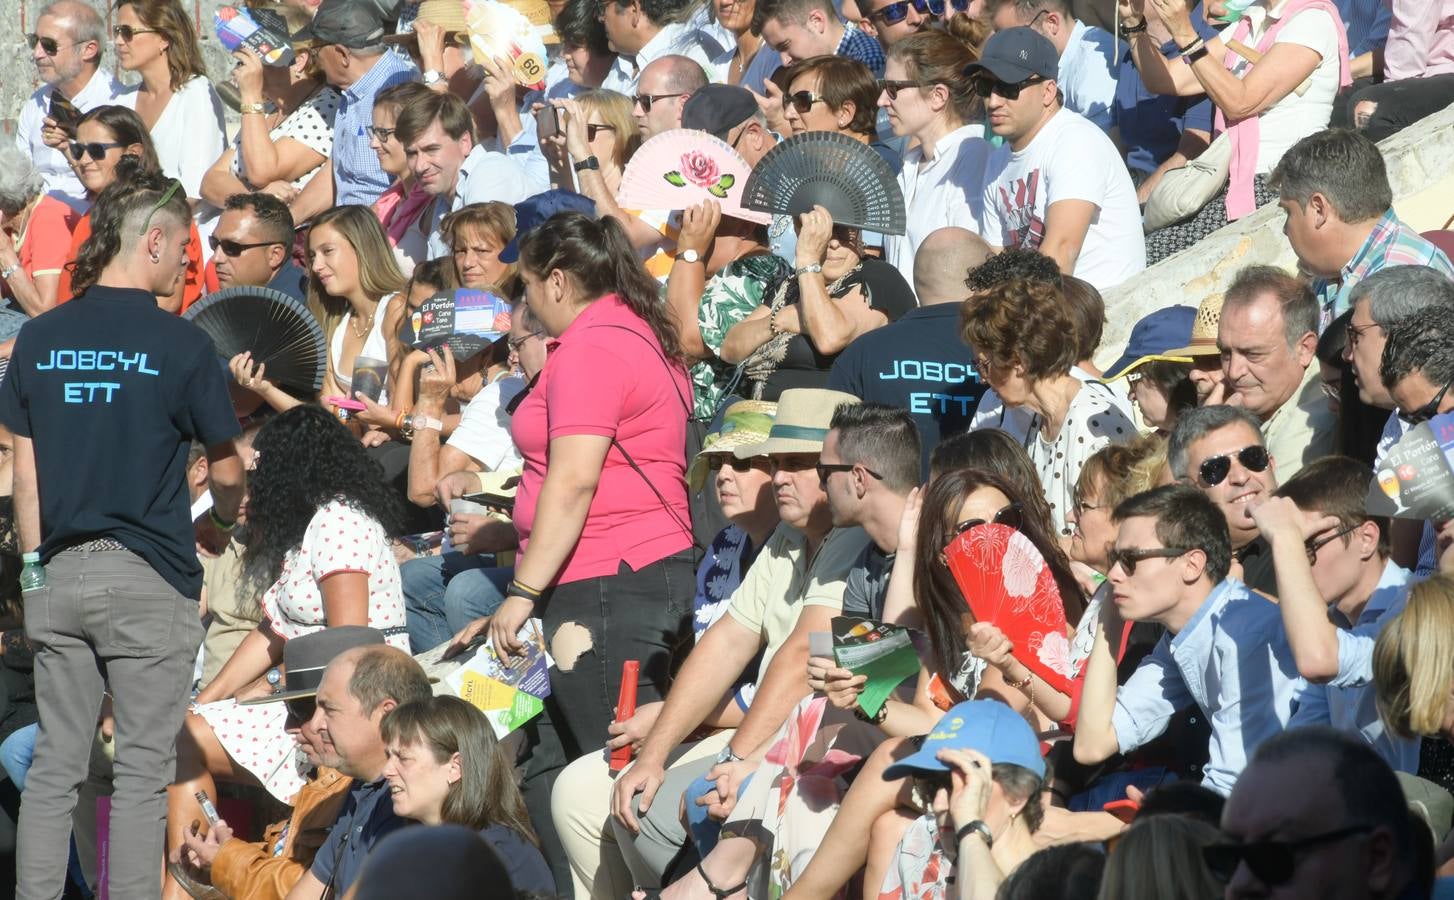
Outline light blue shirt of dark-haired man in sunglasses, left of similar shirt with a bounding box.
[1111,579,1307,795]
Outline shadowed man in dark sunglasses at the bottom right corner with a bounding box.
[1202,728,1429,900]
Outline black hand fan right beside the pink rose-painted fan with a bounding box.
[742,131,907,234]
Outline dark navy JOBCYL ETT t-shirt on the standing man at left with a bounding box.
[0,286,240,598]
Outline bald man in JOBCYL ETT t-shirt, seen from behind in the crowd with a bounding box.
[829,227,990,477]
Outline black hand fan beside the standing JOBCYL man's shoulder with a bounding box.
[182,286,327,393]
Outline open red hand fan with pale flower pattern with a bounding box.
[944,523,1073,692]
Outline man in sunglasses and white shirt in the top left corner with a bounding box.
[15,0,125,209]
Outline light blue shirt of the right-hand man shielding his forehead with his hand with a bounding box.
[1288,560,1419,775]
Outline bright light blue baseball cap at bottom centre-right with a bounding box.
[884,699,1045,781]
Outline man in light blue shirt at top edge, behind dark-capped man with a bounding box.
[987,0,1116,134]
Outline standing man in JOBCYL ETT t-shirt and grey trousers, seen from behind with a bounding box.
[0,176,243,897]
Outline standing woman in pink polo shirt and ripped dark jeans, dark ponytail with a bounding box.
[457,212,695,759]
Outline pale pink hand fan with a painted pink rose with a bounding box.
[616,128,772,225]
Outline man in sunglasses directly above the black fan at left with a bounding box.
[208,193,307,302]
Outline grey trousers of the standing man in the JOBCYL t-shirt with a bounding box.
[16,550,202,900]
